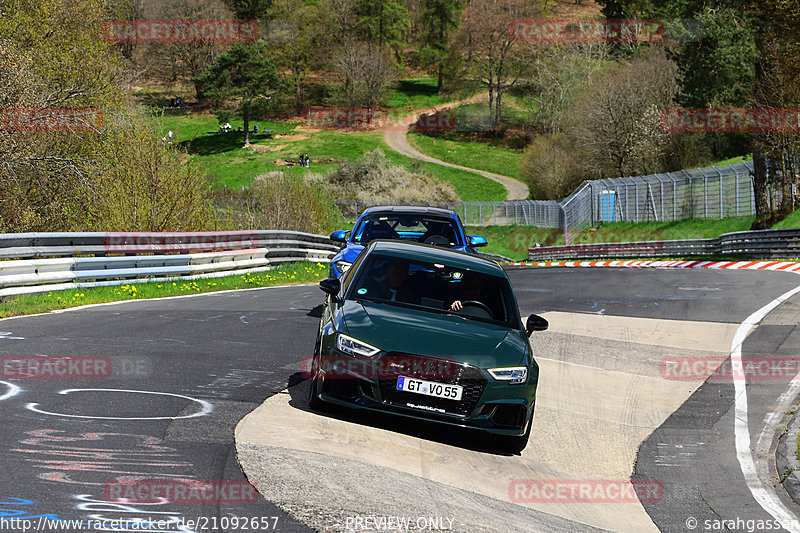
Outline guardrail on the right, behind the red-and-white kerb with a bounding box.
[528,228,800,261]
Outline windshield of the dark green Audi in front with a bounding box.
[347,254,519,328]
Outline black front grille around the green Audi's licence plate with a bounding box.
[378,353,486,416]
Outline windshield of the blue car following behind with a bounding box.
[352,214,461,246]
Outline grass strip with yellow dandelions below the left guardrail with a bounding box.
[0,262,328,318]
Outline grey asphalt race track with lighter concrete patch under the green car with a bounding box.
[0,268,800,531]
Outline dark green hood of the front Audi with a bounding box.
[342,300,528,368]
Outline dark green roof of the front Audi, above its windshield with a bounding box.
[367,239,507,277]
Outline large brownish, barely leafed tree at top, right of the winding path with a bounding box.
[455,0,537,131]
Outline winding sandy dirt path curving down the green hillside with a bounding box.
[383,94,528,200]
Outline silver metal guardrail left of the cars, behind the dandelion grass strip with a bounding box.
[0,230,339,298]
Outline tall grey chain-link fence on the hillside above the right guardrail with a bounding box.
[337,161,781,230]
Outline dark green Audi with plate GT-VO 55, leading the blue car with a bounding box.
[309,240,547,453]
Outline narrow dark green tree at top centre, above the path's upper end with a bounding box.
[420,0,465,93]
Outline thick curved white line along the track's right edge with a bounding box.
[731,286,800,533]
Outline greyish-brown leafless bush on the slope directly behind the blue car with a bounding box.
[317,149,459,203]
